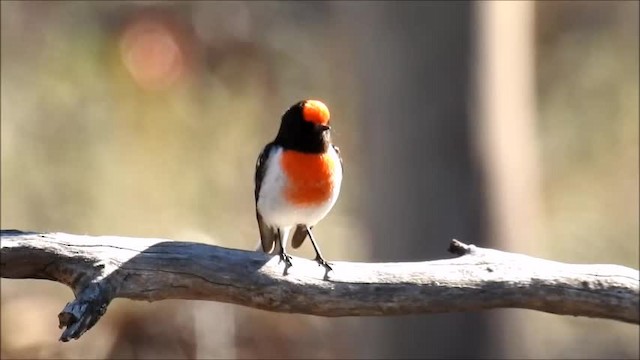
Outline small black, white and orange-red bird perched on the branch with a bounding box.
[254,100,343,271]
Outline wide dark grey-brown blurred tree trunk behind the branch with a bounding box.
[340,2,500,358]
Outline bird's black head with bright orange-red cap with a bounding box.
[274,100,331,153]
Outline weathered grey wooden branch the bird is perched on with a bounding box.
[0,230,640,341]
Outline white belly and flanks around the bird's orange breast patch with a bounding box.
[257,147,342,228]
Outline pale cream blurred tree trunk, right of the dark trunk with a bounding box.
[473,1,545,358]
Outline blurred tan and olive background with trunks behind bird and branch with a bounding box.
[0,1,639,359]
